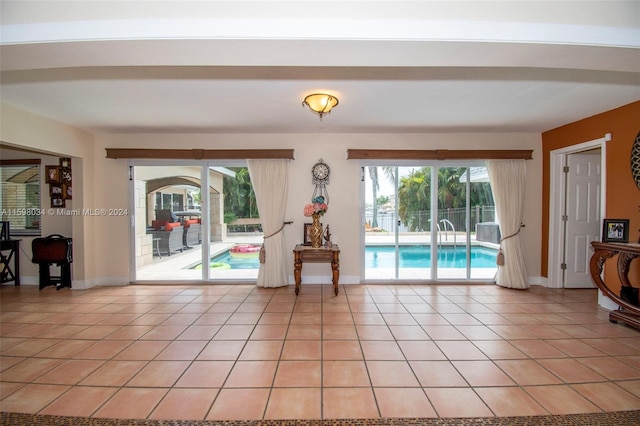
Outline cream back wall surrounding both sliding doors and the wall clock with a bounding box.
[95,133,542,283]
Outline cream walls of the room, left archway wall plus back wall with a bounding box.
[0,104,542,288]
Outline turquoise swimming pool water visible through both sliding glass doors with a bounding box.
[204,245,497,269]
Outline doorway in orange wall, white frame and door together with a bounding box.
[548,135,610,288]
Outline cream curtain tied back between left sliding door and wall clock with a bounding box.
[247,160,289,287]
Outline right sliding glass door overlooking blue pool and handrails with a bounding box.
[363,162,499,280]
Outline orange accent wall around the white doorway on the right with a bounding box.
[540,101,640,283]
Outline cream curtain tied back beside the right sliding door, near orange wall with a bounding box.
[487,160,529,288]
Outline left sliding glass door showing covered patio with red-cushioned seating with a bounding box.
[132,161,262,283]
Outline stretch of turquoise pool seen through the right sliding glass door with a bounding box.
[364,245,498,269]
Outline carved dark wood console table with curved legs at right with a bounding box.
[590,241,640,328]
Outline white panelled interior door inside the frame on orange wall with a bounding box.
[564,150,601,288]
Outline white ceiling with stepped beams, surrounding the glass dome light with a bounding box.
[0,0,640,133]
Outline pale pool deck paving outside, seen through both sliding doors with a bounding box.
[136,232,498,282]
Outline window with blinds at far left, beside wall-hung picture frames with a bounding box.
[0,160,42,235]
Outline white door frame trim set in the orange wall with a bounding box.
[547,133,611,288]
